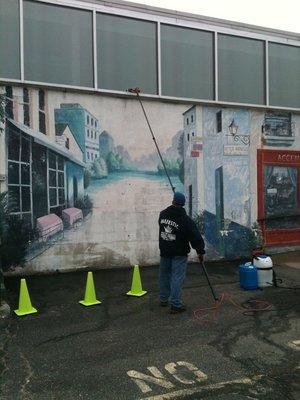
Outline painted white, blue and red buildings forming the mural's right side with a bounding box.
[183,106,300,259]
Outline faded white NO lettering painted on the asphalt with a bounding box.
[127,361,207,393]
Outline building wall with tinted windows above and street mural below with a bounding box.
[0,0,300,273]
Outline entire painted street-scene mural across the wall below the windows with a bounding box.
[0,86,300,273]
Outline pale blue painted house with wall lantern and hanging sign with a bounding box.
[203,108,251,258]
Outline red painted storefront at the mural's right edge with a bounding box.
[257,150,300,246]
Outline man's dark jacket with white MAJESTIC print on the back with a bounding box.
[158,205,205,257]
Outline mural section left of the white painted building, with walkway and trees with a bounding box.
[1,88,188,272]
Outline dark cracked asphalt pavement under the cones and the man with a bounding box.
[0,262,300,400]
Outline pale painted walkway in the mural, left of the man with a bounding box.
[26,176,179,271]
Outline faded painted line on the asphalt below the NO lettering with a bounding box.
[140,375,262,400]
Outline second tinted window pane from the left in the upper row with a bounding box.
[24,0,93,86]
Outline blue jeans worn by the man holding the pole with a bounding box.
[159,256,187,307]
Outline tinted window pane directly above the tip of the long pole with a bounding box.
[97,14,157,94]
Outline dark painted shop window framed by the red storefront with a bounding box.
[264,166,300,229]
